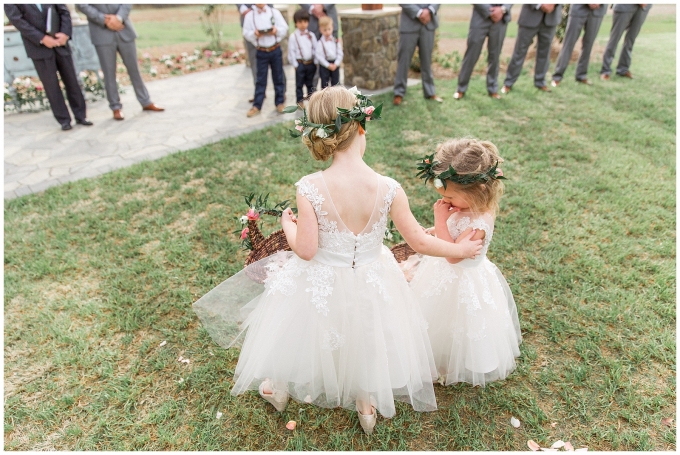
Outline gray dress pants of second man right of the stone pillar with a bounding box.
[458,21,508,93]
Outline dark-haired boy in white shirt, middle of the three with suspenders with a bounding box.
[288,9,316,107]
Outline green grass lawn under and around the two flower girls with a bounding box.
[4,33,676,450]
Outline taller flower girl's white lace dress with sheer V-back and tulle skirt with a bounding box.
[194,172,437,417]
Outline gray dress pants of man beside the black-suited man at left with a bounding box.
[95,35,151,110]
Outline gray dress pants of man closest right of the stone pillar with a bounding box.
[394,27,435,98]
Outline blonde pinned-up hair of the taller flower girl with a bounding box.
[302,85,359,161]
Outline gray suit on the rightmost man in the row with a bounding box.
[600,5,652,75]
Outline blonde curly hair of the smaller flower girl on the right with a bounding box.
[433,138,505,215]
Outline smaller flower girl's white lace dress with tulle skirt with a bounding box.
[410,212,522,386]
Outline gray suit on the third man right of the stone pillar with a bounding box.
[503,4,562,87]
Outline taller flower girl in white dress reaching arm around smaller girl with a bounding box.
[194,86,482,433]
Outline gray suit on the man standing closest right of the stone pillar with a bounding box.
[394,4,439,98]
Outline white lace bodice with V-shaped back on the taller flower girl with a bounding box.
[295,172,400,255]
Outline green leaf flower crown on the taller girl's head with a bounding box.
[283,87,382,138]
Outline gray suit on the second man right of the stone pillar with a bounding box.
[458,4,512,93]
